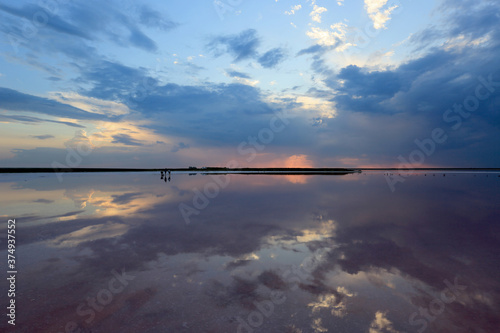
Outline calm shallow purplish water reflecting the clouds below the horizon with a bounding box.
[0,173,500,333]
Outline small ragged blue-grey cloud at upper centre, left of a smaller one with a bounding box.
[207,29,260,62]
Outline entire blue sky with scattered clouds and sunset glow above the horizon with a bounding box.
[0,0,500,168]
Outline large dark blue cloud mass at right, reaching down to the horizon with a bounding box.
[311,1,500,167]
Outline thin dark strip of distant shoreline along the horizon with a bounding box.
[0,167,500,175]
